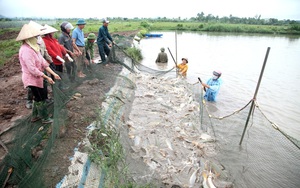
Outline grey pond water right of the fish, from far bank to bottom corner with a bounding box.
[139,32,300,187]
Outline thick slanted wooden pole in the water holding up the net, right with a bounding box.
[240,47,270,145]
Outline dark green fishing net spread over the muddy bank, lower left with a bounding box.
[0,35,140,187]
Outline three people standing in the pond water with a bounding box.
[155,47,222,101]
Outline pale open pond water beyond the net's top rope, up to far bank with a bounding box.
[139,32,300,140]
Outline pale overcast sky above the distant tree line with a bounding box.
[0,0,300,20]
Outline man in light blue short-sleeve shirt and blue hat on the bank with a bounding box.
[72,19,86,78]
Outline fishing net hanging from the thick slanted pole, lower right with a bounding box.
[192,81,300,188]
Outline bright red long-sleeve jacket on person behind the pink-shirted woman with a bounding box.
[43,35,67,65]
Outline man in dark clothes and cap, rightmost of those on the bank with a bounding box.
[97,19,115,65]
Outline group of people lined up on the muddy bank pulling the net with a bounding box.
[16,19,115,124]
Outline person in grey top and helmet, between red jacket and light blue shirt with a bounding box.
[58,22,79,82]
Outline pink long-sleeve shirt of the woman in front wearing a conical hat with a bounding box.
[19,43,49,88]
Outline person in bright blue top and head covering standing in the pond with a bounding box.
[201,71,222,101]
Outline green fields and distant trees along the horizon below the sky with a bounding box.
[0,12,300,66]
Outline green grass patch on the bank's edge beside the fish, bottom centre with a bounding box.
[89,106,153,188]
